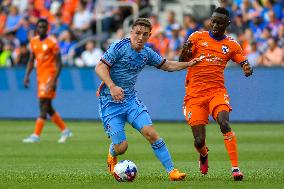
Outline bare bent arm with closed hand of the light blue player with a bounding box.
[96,61,124,102]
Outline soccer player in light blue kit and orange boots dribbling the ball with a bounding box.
[96,18,200,180]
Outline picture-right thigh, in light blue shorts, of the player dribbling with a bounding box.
[127,98,153,132]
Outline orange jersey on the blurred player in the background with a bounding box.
[30,36,59,79]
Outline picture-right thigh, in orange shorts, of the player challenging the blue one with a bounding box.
[209,92,232,120]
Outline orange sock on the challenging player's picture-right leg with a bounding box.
[223,132,238,167]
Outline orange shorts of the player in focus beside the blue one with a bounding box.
[183,92,232,126]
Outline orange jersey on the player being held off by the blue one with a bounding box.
[185,31,247,100]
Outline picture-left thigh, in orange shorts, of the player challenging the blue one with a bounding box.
[183,101,209,126]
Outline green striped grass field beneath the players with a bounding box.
[0,121,284,189]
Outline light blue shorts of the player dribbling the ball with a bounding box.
[100,97,152,144]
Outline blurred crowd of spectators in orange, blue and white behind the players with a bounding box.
[0,0,284,67]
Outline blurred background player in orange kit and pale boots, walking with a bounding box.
[23,19,72,143]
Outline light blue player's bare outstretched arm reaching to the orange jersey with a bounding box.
[161,58,201,72]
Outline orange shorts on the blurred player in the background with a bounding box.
[37,74,56,99]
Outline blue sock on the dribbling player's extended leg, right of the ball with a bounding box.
[151,138,174,173]
